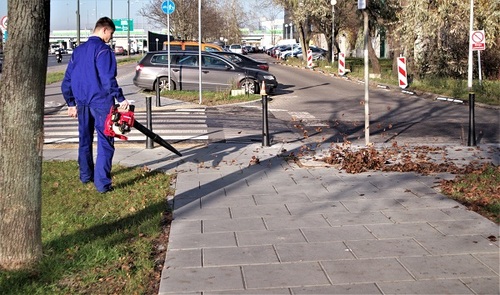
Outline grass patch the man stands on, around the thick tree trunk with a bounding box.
[0,161,171,294]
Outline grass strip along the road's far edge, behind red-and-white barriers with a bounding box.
[287,58,500,105]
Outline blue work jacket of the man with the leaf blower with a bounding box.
[61,36,125,111]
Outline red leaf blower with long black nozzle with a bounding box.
[104,104,182,157]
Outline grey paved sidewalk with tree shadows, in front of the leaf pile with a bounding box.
[44,143,500,295]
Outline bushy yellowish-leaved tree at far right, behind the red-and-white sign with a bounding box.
[396,0,500,78]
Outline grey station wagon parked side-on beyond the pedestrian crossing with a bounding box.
[133,51,278,94]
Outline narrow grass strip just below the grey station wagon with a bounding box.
[161,90,261,106]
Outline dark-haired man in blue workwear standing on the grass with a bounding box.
[61,17,128,193]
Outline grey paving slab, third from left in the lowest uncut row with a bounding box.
[321,258,413,284]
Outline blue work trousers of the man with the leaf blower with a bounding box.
[77,106,115,192]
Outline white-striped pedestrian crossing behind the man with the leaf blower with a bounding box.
[44,108,208,144]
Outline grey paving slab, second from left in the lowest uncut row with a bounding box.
[243,262,330,289]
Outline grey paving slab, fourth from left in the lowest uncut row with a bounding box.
[399,254,495,280]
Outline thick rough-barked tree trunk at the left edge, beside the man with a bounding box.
[0,0,50,270]
